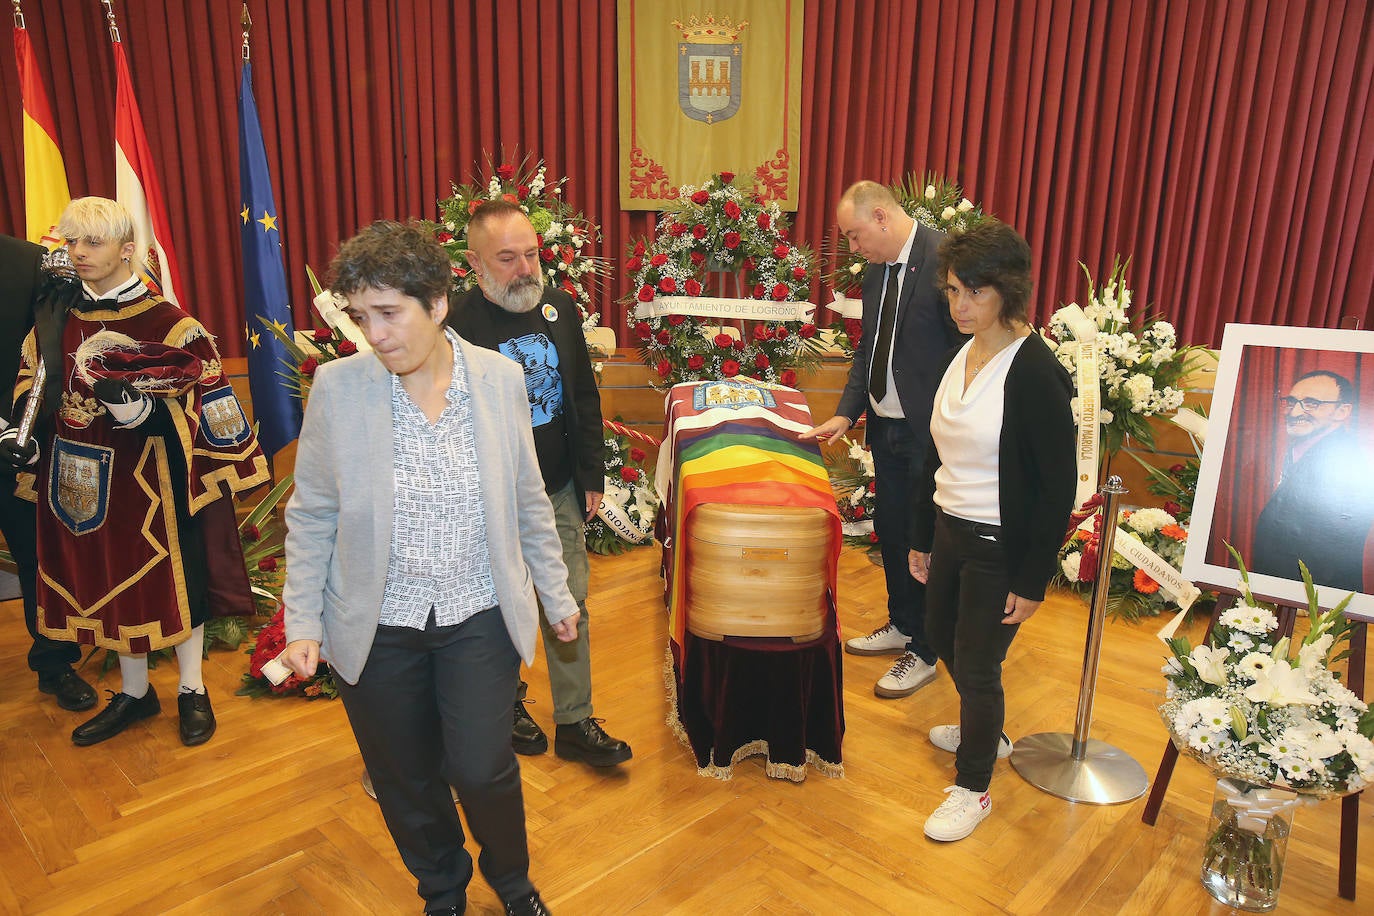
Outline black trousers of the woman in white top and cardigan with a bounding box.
[926,512,1021,792]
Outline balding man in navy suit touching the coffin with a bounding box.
[804,181,965,698]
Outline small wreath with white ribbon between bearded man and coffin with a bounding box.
[585,420,658,555]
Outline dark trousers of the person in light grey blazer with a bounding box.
[339,608,533,909]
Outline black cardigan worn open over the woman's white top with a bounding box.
[911,332,1077,602]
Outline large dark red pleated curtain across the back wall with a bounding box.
[0,0,1374,356]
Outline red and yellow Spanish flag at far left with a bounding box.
[14,26,71,242]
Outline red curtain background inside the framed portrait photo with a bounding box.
[1206,346,1374,580]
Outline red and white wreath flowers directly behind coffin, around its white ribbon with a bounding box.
[625,172,820,387]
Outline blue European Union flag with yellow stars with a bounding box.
[239,60,301,456]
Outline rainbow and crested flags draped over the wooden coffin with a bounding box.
[655,379,841,645]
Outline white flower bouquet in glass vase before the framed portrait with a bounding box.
[1160,549,1374,797]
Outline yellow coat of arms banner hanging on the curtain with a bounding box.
[617,0,802,210]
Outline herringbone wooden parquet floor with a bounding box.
[0,548,1374,916]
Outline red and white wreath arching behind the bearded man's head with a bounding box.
[434,157,610,328]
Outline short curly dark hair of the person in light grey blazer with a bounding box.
[330,220,452,309]
